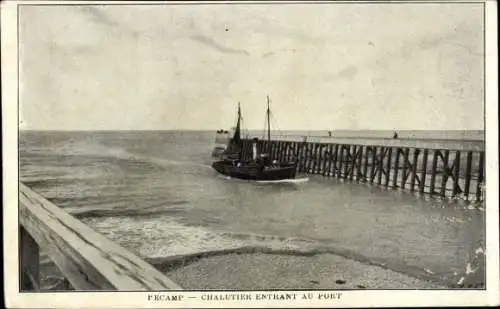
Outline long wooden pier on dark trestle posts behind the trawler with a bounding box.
[243,136,485,201]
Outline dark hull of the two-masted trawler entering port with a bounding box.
[212,161,297,181]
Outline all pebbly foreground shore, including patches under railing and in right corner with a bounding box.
[41,248,484,290]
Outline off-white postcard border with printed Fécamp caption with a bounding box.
[1,0,500,308]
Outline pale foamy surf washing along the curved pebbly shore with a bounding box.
[71,207,456,287]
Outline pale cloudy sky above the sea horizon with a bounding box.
[19,3,484,130]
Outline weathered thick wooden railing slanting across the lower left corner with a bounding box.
[19,183,181,291]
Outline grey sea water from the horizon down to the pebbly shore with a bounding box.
[20,132,484,284]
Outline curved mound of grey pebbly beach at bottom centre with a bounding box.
[157,253,449,290]
